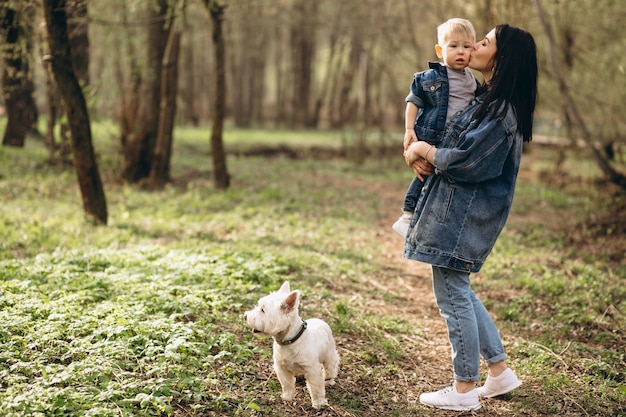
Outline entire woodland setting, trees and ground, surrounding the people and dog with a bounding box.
[0,0,626,417]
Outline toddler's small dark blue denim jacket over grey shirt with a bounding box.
[405,62,450,145]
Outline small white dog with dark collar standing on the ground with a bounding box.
[245,281,339,408]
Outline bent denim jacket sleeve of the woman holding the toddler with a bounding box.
[434,104,517,182]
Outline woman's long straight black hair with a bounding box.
[476,24,537,142]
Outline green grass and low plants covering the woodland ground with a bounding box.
[0,124,626,416]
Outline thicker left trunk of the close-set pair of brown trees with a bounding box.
[122,0,172,182]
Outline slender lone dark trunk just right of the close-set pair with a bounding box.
[205,0,230,190]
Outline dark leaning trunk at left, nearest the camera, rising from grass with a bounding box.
[43,0,107,224]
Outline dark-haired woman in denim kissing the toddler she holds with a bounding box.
[404,25,537,411]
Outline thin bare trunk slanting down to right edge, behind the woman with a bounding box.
[535,0,626,189]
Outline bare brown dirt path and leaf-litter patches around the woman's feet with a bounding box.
[225,145,626,417]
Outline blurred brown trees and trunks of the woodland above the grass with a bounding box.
[0,0,626,223]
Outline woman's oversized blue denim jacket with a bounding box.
[404,94,523,272]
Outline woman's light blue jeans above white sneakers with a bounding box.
[432,265,507,382]
